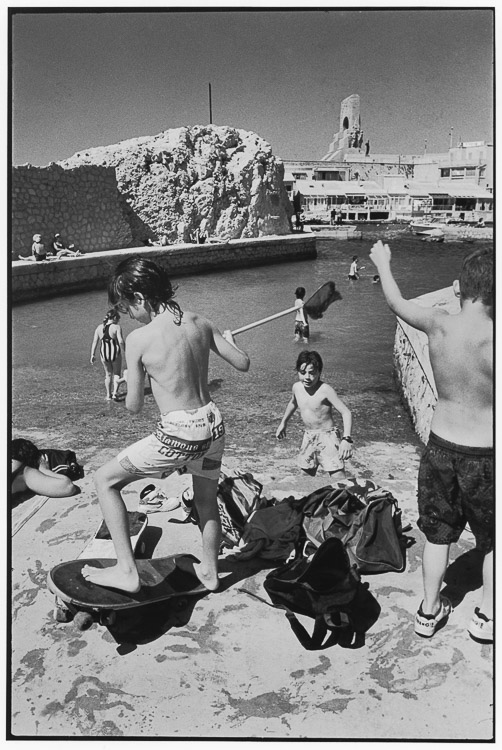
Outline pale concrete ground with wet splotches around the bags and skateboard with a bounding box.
[11,443,493,741]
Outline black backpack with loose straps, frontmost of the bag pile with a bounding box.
[255,538,380,651]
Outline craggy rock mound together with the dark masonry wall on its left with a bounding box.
[13,125,292,256]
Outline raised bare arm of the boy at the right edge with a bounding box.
[370,240,446,333]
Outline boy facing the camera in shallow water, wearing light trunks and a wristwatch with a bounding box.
[275,351,353,478]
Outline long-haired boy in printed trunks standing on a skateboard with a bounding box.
[82,256,249,593]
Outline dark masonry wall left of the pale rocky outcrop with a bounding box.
[11,163,133,260]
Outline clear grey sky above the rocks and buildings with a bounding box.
[8,3,494,166]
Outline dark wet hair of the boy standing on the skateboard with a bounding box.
[108,255,183,325]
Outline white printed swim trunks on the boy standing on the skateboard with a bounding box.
[117,401,225,479]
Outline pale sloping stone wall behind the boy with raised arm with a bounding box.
[394,287,460,443]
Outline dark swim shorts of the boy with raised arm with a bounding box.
[418,432,495,553]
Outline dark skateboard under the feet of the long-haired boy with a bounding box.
[47,555,208,630]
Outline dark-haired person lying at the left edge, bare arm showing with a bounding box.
[11,438,80,497]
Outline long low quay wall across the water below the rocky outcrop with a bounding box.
[11,235,317,302]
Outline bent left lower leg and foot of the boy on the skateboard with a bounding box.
[82,458,140,593]
